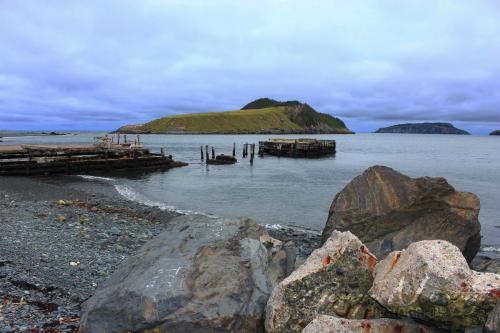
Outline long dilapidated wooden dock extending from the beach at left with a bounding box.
[0,138,187,176]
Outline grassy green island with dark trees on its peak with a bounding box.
[116,98,353,134]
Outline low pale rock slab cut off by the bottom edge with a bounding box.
[302,315,440,333]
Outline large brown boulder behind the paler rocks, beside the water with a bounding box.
[322,166,481,261]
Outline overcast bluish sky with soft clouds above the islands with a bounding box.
[0,0,500,134]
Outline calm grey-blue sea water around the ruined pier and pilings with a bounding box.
[4,133,500,251]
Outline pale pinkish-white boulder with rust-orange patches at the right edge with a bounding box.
[370,240,500,331]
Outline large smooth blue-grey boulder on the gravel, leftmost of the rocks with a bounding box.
[81,216,295,333]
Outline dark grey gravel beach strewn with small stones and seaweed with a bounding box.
[0,176,320,332]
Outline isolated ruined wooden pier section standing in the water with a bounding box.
[259,138,336,158]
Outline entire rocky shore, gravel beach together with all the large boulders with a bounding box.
[0,166,500,333]
